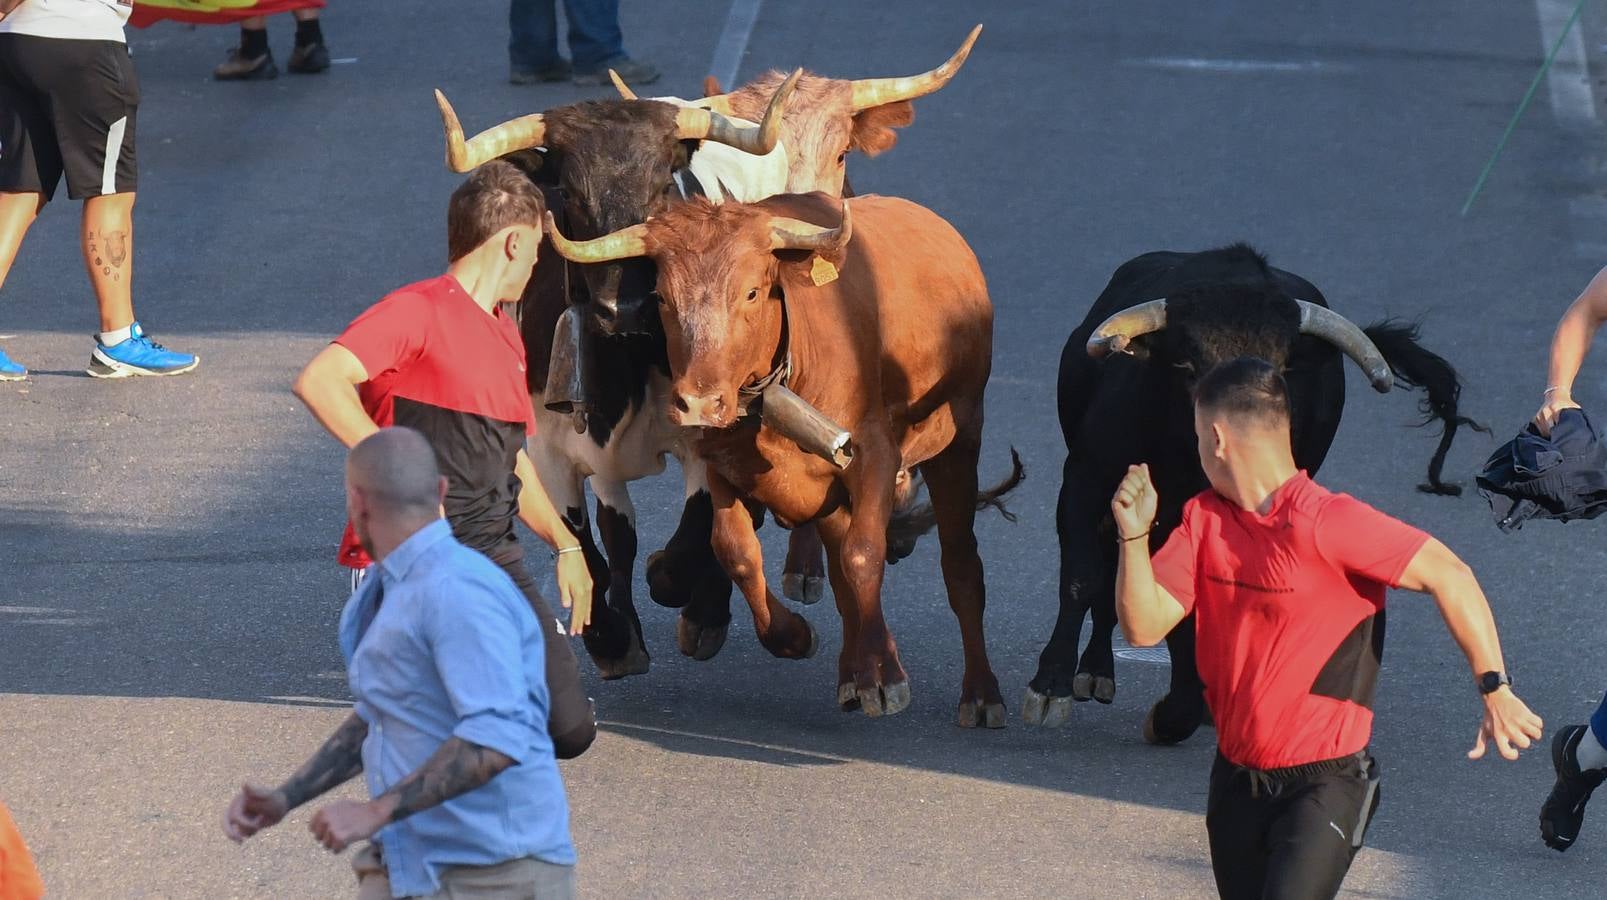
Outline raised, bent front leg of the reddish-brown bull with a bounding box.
[709,473,820,659]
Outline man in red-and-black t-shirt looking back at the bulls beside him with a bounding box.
[294,161,596,759]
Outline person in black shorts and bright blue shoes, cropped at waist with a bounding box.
[0,0,201,381]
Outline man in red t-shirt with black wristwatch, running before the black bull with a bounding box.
[1110,358,1541,900]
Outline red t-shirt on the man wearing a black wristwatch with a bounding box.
[1155,473,1429,770]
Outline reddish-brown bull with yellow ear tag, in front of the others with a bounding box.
[553,194,1004,728]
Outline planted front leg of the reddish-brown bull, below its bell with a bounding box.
[818,447,906,717]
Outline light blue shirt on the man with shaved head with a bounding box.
[341,519,575,897]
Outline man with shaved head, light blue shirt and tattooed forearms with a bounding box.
[223,428,575,900]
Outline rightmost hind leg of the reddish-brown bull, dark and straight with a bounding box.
[921,434,1004,728]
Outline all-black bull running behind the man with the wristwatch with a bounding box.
[1022,244,1483,744]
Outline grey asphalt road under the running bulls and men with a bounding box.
[0,0,1607,900]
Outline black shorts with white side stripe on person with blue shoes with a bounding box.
[0,32,140,199]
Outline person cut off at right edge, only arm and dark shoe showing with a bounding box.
[1535,268,1607,852]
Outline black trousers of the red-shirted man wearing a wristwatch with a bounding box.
[1205,752,1379,900]
